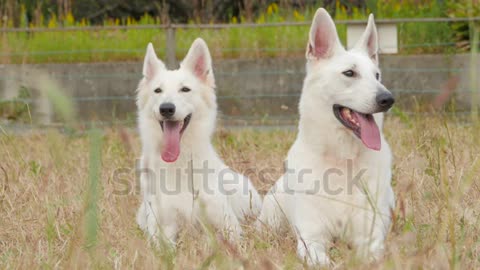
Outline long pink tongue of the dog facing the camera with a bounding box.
[162,121,182,162]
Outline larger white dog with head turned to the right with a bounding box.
[259,9,394,265]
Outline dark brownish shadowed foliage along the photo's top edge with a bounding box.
[0,0,344,27]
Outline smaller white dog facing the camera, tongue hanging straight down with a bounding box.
[137,39,262,247]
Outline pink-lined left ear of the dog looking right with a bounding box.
[306,8,343,59]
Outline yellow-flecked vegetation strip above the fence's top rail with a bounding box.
[0,0,480,27]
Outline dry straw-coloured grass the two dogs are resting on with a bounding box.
[0,117,480,269]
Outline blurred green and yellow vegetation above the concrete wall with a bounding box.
[0,0,480,63]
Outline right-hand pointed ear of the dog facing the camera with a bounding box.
[181,38,215,87]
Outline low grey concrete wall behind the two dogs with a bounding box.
[0,55,480,124]
